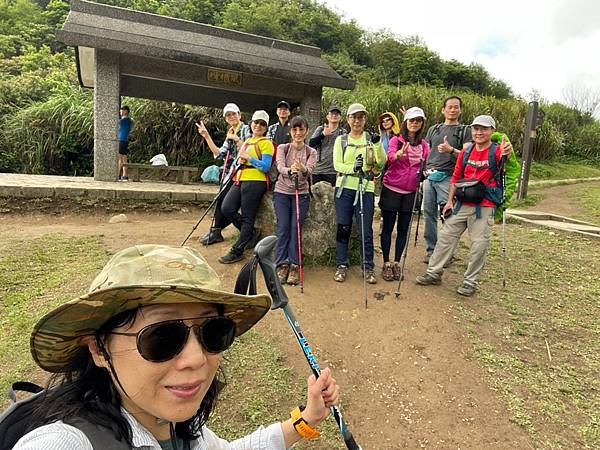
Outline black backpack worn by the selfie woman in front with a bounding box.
[0,381,131,450]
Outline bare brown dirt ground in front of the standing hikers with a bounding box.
[0,211,536,450]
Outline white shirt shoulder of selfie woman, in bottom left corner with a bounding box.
[13,422,94,450]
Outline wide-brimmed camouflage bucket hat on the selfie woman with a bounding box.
[30,245,271,372]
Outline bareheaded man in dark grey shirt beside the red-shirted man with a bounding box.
[423,95,471,264]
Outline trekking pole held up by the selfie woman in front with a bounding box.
[250,236,362,450]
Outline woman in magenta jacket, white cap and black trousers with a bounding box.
[379,107,429,281]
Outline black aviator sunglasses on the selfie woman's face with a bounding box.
[110,317,236,362]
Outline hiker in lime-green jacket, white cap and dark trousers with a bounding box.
[333,103,386,284]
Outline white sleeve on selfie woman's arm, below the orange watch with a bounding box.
[200,422,293,450]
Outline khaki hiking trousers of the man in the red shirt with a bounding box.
[427,205,494,286]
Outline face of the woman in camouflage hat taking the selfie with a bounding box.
[98,304,223,431]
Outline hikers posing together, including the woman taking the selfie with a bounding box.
[0,96,519,450]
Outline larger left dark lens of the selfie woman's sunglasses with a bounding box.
[137,321,189,362]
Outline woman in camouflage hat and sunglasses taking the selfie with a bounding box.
[14,245,339,450]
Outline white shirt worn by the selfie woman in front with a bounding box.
[13,409,292,450]
